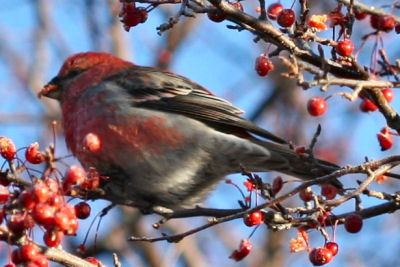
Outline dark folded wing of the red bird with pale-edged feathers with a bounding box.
[104,66,287,147]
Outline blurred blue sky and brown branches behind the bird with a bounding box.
[0,0,400,267]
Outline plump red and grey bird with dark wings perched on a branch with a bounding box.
[39,52,340,213]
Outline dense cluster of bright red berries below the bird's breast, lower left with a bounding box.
[0,136,101,267]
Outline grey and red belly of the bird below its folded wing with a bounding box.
[67,107,222,208]
